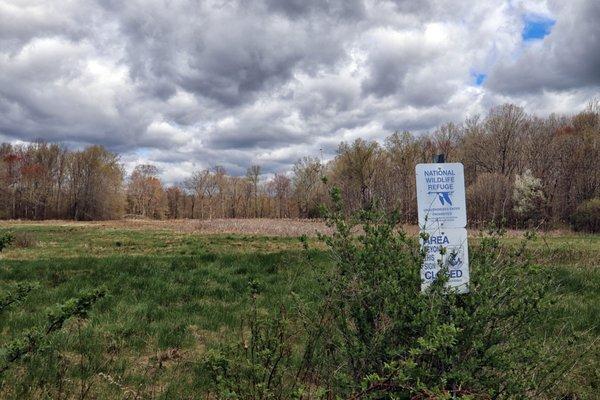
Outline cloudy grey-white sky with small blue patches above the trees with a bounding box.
[0,0,600,182]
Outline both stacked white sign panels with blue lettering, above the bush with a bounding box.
[415,163,469,293]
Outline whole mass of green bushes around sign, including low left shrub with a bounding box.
[201,189,573,399]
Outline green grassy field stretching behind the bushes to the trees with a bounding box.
[0,224,600,399]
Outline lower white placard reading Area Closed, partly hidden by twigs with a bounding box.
[421,228,469,293]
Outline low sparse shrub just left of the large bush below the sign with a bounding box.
[198,281,325,400]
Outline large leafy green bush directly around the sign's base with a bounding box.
[314,192,555,398]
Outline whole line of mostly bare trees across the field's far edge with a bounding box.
[0,102,600,226]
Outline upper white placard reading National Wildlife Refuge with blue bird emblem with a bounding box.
[415,163,467,230]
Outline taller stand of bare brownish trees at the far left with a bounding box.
[0,143,125,220]
